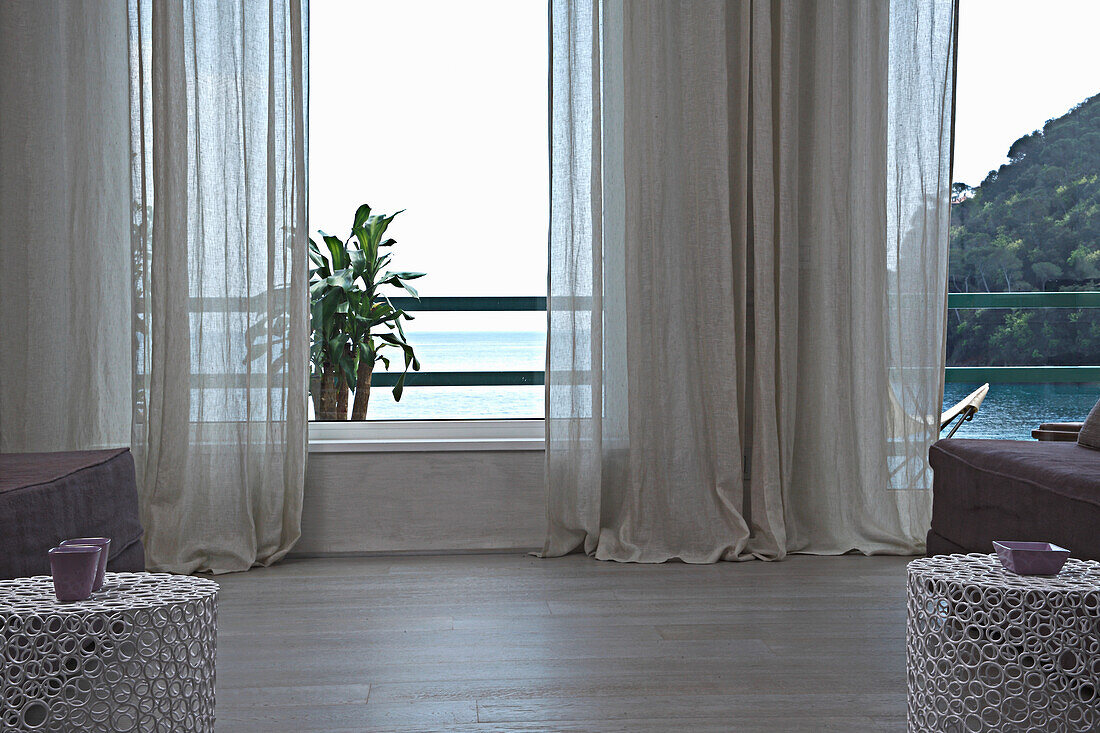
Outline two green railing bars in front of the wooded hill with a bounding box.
[946,291,1100,384]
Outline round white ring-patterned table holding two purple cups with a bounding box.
[0,572,218,733]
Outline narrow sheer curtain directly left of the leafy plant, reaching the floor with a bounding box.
[129,0,308,572]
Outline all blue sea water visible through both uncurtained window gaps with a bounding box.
[367,331,1100,440]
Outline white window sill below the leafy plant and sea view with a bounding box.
[309,419,545,453]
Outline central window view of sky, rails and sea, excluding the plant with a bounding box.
[309,0,549,419]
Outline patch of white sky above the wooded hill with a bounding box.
[954,0,1100,186]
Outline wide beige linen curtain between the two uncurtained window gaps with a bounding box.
[543,0,955,562]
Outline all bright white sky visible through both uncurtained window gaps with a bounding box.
[309,0,1100,308]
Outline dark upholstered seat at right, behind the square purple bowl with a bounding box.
[928,439,1100,560]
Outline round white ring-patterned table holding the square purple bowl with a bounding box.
[905,555,1100,733]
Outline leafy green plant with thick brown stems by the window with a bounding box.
[309,204,424,420]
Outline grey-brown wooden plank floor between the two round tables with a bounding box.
[218,555,910,733]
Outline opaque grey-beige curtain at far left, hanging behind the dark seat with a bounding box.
[0,0,130,452]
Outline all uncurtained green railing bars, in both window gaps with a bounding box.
[371,291,1100,386]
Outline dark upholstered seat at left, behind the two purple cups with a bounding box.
[0,448,145,579]
